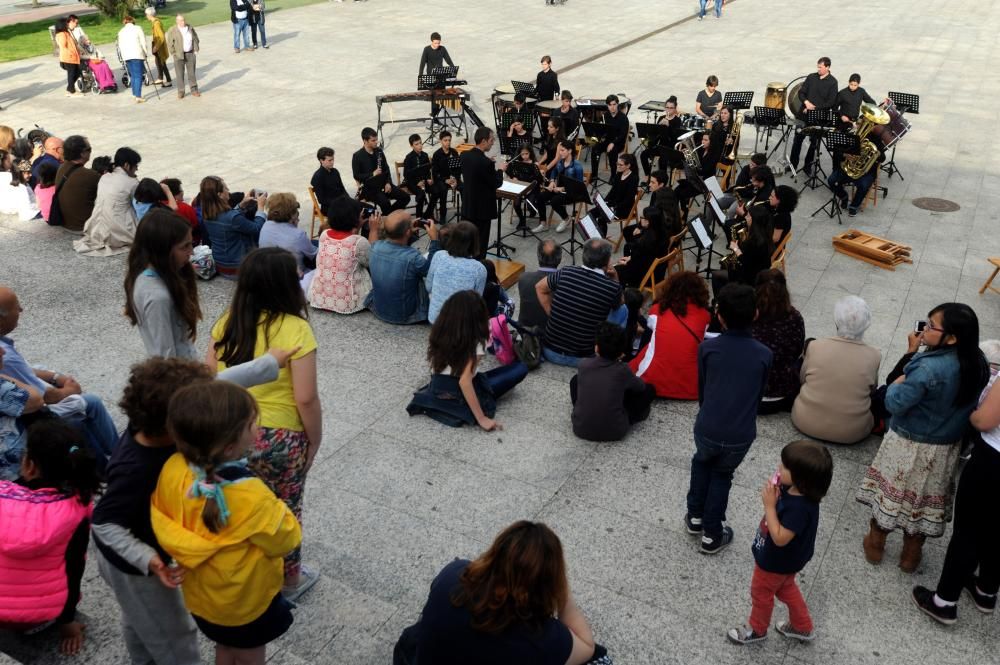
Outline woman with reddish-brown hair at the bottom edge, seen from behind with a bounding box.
[395,521,607,665]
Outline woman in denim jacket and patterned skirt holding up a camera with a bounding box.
[857,303,989,573]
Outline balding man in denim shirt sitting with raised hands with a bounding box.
[365,210,441,324]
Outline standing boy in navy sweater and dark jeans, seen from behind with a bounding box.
[684,283,771,554]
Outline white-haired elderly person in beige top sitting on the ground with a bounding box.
[792,296,882,443]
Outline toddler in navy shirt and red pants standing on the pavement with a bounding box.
[727,441,833,644]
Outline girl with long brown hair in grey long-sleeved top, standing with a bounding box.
[125,209,201,360]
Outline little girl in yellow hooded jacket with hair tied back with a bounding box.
[150,381,302,665]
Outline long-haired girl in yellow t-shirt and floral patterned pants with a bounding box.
[205,247,323,601]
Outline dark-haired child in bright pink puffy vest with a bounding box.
[0,418,100,655]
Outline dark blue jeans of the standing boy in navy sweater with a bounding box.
[687,434,753,538]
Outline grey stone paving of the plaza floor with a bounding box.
[0,0,1000,665]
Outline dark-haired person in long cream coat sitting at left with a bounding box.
[73,148,142,256]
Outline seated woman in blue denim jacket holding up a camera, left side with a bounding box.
[198,175,267,279]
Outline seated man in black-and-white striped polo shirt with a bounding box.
[535,238,627,367]
